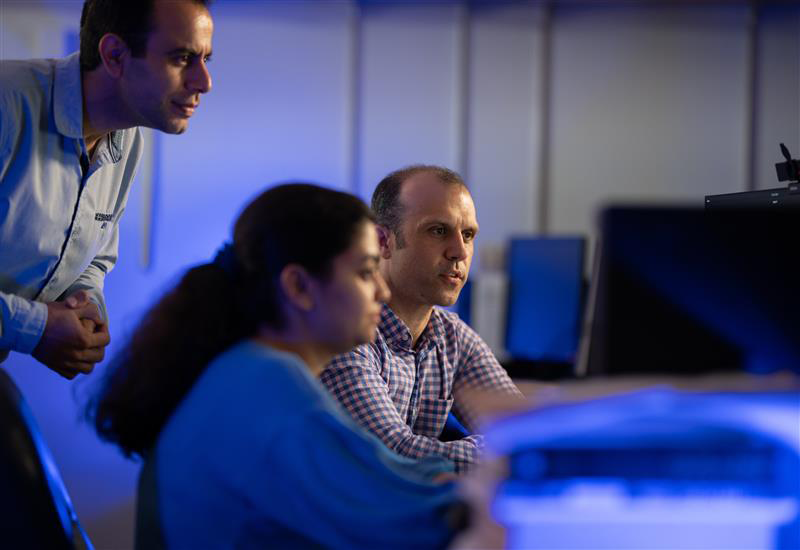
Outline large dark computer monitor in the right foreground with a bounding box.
[580,207,800,375]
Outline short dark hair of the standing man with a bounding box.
[80,0,211,71]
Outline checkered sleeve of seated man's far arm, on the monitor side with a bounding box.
[453,319,522,431]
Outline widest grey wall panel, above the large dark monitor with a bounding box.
[551,3,748,237]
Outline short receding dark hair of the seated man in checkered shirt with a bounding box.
[372,164,467,247]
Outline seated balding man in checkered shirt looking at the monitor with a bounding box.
[321,165,520,472]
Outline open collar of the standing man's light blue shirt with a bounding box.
[53,52,125,163]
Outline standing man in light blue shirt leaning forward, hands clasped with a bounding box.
[0,0,213,378]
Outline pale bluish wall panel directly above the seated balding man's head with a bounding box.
[359,2,459,200]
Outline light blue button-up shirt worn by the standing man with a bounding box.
[0,53,143,361]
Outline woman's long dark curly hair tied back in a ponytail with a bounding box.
[86,183,373,456]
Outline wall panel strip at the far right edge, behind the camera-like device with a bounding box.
[755,4,800,189]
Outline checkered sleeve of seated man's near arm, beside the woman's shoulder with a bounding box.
[320,345,483,473]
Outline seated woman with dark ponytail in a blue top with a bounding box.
[89,184,461,548]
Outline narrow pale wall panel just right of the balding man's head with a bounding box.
[468,2,544,246]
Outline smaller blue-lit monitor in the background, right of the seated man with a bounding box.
[506,237,585,363]
